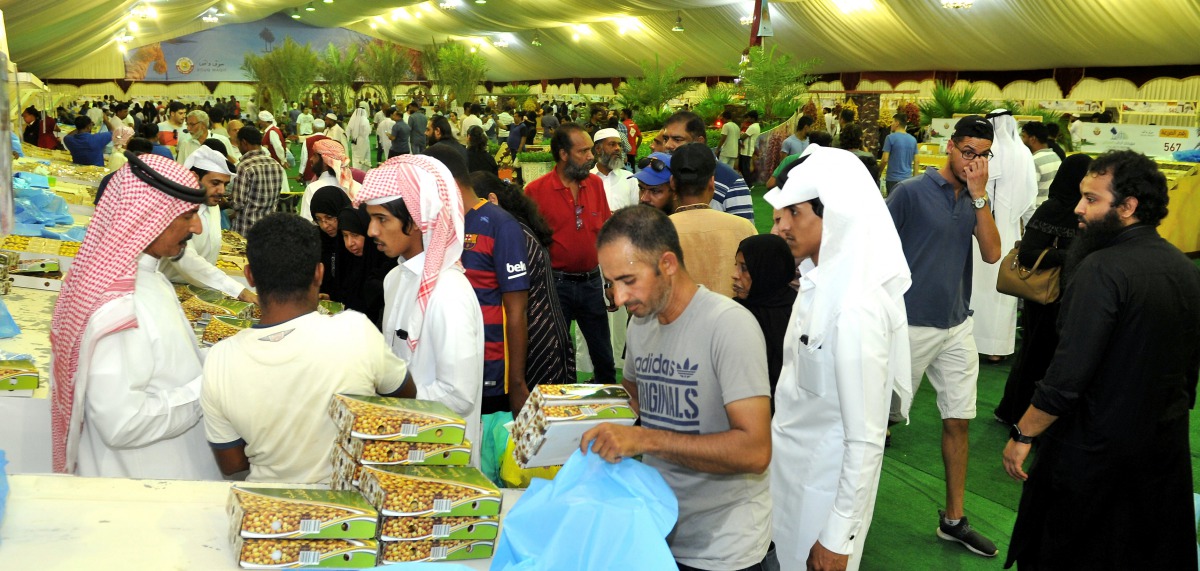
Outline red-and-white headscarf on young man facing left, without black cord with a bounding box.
[354,155,463,350]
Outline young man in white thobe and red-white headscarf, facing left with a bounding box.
[354,155,484,468]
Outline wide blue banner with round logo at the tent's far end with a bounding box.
[125,12,419,82]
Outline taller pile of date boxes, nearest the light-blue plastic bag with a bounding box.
[329,395,500,564]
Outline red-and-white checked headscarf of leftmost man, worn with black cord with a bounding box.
[50,155,199,474]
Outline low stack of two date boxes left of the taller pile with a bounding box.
[228,487,379,569]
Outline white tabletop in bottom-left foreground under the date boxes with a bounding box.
[0,475,523,571]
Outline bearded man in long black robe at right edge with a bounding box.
[1003,151,1200,570]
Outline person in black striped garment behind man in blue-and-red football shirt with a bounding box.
[470,173,573,390]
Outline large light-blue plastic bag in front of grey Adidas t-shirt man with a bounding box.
[491,451,679,571]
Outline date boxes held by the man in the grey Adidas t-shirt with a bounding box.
[512,385,637,468]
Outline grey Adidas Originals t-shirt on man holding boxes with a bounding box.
[624,286,770,569]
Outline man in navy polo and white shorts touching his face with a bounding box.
[887,115,1000,557]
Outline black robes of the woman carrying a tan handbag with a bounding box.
[995,155,1092,425]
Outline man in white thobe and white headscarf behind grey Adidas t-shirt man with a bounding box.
[764,145,912,570]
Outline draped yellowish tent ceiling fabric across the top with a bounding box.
[7,0,1200,82]
